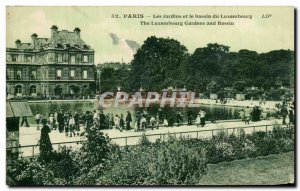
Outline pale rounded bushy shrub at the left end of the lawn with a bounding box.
[149,141,207,185]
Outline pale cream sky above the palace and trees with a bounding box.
[6,6,294,64]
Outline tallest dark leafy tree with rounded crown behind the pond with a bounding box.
[130,36,189,91]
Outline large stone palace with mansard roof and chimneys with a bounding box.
[6,25,95,99]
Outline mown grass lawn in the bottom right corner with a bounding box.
[199,152,294,185]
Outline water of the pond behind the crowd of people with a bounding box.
[29,100,276,123]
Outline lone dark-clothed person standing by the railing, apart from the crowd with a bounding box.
[39,118,53,160]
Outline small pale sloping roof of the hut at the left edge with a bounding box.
[6,101,33,117]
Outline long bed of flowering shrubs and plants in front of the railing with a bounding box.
[7,125,294,185]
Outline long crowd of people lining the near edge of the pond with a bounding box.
[31,108,206,137]
